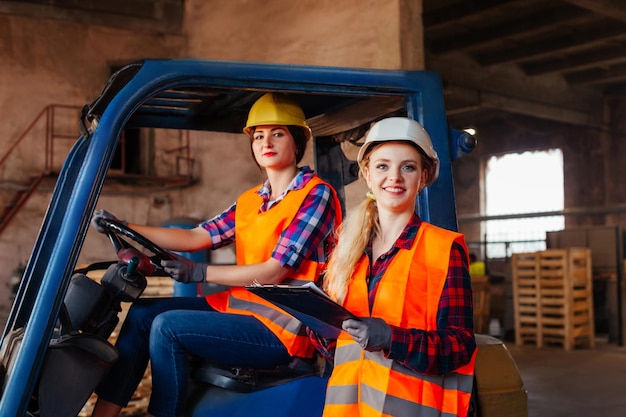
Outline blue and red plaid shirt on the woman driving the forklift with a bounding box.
[200,166,335,271]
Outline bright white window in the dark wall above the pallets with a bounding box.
[484,149,565,258]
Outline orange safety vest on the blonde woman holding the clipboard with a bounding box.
[324,223,476,417]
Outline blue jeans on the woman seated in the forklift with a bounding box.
[96,297,291,417]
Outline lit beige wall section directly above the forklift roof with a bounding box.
[185,0,424,69]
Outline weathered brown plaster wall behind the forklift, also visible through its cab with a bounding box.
[0,0,424,310]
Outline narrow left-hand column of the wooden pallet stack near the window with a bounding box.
[512,253,542,346]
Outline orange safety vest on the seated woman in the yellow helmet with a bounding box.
[206,175,341,358]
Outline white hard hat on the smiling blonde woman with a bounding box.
[356,117,439,185]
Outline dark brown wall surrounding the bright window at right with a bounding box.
[453,110,626,342]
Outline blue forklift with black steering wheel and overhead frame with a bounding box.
[0,59,527,417]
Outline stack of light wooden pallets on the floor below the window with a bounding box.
[512,248,595,350]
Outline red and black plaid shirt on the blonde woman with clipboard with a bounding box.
[309,215,476,375]
